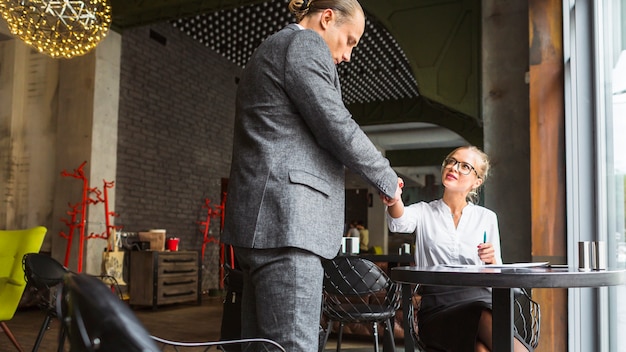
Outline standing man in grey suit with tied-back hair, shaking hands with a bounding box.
[222,0,400,352]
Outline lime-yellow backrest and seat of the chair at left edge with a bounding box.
[0,226,47,321]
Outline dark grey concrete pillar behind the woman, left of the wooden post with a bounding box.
[481,0,531,262]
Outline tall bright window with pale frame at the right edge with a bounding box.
[563,0,626,352]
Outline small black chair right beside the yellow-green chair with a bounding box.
[22,253,68,352]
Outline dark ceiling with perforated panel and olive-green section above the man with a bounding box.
[111,0,482,165]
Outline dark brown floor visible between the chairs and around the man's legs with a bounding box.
[0,296,404,352]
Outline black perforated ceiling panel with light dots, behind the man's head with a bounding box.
[172,0,418,104]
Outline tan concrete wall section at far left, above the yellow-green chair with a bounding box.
[0,26,58,242]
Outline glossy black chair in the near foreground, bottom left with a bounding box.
[57,273,285,352]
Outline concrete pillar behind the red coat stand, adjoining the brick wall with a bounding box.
[52,31,122,274]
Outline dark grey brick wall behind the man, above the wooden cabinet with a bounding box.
[115,23,241,289]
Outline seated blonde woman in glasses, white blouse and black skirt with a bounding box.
[387,146,531,351]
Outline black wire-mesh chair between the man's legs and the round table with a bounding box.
[319,256,400,352]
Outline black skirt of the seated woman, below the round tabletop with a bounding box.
[418,286,533,352]
